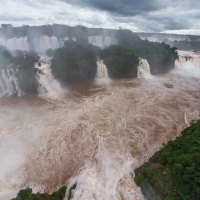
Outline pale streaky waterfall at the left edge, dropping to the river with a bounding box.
[0,64,23,96]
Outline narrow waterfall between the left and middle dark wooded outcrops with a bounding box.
[96,60,111,85]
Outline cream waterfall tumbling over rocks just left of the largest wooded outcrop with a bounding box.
[35,57,63,98]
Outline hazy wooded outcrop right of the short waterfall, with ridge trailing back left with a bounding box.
[117,30,178,74]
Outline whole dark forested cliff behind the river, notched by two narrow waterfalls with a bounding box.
[47,36,178,84]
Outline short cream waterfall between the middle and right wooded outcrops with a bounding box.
[137,58,152,79]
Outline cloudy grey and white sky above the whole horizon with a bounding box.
[0,0,200,34]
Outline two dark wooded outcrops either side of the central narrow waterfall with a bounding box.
[50,41,139,84]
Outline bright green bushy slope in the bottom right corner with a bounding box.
[135,120,200,200]
